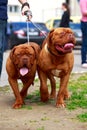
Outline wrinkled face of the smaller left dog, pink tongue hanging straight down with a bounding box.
[10,45,35,76]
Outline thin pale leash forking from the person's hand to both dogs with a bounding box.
[24,10,47,44]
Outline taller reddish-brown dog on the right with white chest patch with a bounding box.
[38,28,75,107]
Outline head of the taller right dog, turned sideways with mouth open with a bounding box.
[47,28,76,55]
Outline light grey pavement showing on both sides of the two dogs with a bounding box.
[0,50,87,86]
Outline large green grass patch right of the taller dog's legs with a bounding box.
[67,74,87,110]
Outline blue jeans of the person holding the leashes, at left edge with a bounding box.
[0,20,7,76]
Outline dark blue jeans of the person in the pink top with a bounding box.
[81,22,87,64]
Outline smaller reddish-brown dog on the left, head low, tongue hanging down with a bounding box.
[6,43,40,108]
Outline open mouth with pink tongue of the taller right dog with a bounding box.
[55,43,74,53]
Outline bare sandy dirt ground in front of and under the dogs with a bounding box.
[0,79,87,130]
